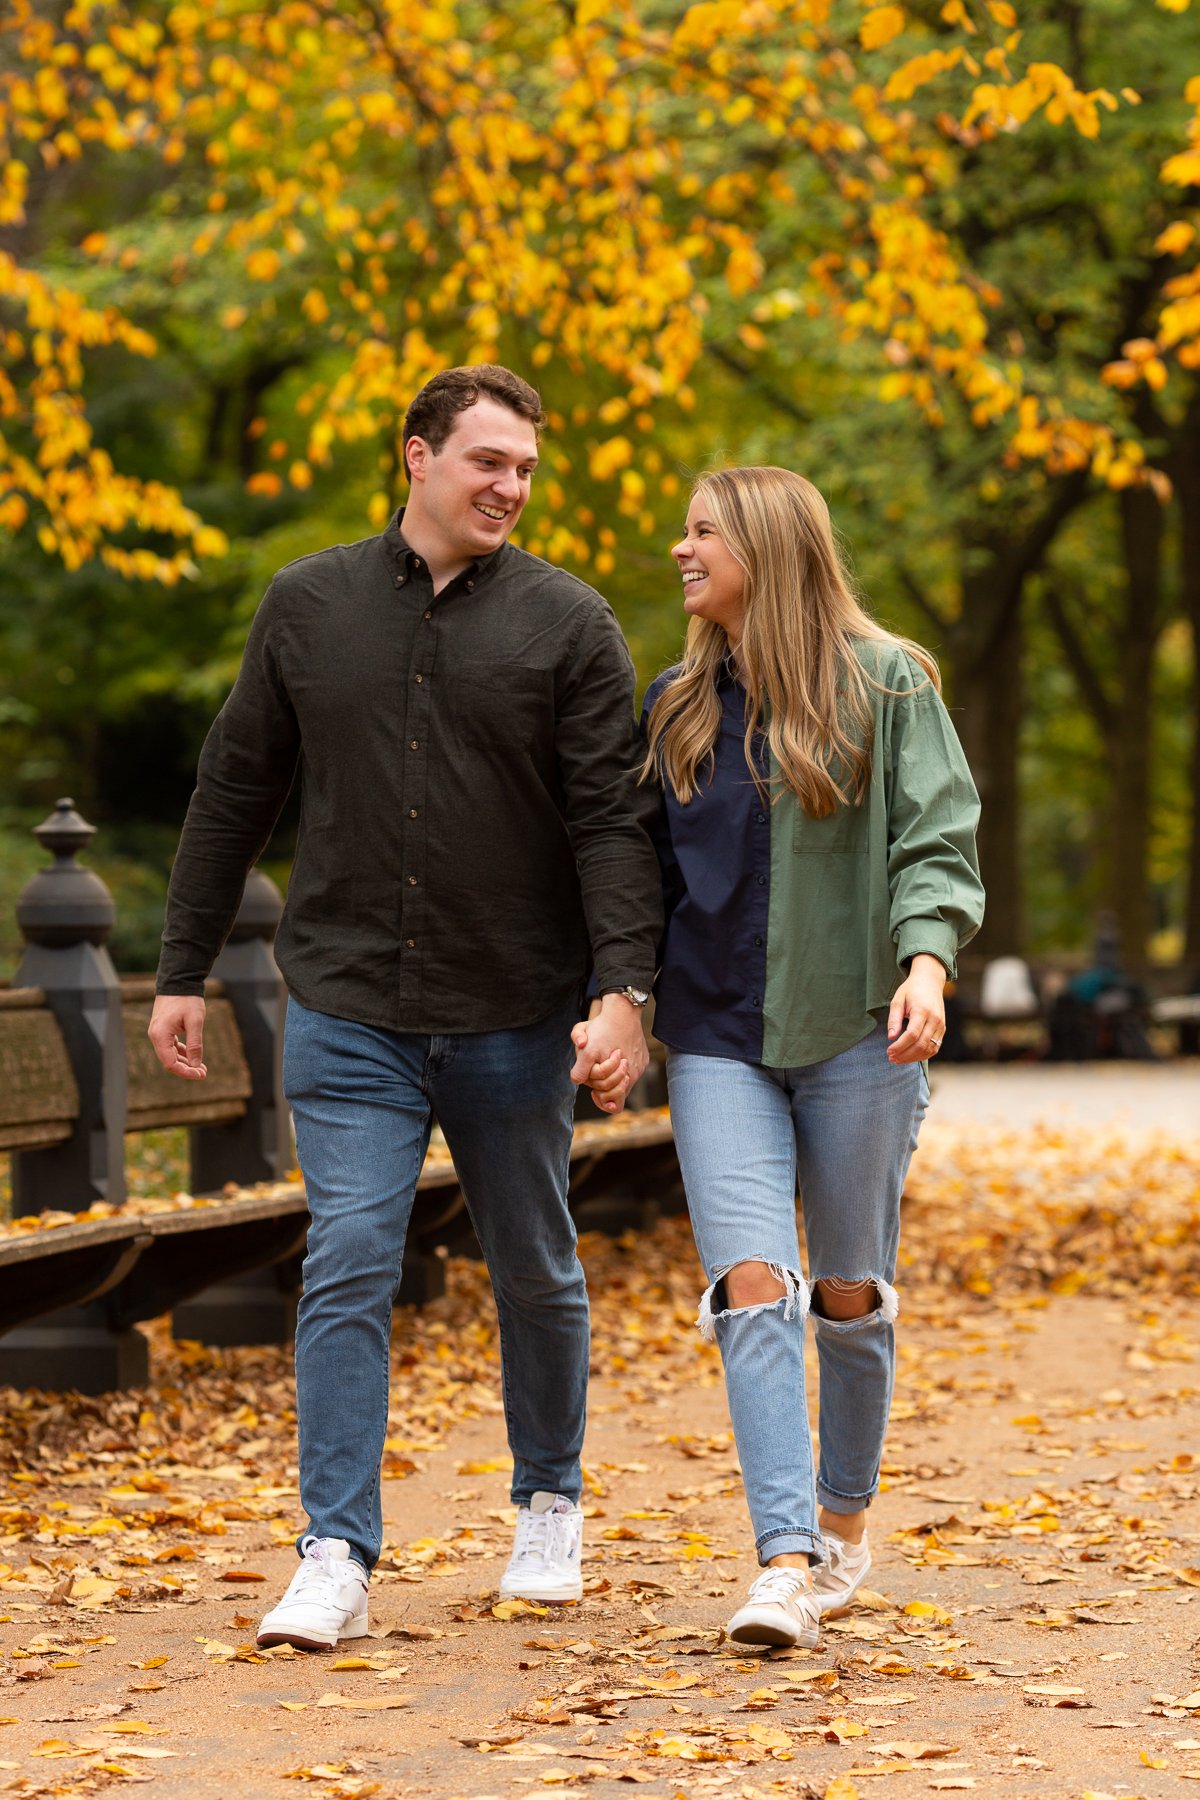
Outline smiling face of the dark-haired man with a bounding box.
[408,398,538,562]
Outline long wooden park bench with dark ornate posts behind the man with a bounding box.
[0,801,678,1393]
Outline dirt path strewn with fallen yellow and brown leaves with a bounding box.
[0,1101,1200,1800]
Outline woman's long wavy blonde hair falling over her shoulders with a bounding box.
[642,468,941,819]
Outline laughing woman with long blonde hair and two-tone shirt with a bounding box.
[644,468,982,1645]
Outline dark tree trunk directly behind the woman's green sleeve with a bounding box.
[948,562,1024,956]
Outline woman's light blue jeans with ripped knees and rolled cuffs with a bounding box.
[667,1026,928,1562]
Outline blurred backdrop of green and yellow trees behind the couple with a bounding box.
[0,0,1200,967]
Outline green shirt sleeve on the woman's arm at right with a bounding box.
[887,684,984,979]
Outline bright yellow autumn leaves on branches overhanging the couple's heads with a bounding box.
[0,0,1200,580]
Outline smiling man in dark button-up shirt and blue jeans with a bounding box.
[149,365,660,1649]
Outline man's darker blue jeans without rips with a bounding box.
[284,999,588,1570]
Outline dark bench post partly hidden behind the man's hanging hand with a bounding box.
[171,869,300,1345]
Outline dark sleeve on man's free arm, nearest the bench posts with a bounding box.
[157,585,300,994]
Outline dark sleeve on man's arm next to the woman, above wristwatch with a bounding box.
[556,601,662,992]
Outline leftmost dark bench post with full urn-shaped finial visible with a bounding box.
[0,799,149,1393]
